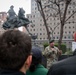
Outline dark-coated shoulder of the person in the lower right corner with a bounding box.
[47,56,76,75]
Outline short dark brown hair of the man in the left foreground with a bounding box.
[0,30,31,70]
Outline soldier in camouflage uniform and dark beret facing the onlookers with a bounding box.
[43,40,61,69]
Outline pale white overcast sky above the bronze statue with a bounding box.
[0,0,31,14]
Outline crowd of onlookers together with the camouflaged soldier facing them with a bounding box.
[0,30,76,75]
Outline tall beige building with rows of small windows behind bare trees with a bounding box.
[27,0,76,48]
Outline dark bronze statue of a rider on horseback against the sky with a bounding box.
[3,6,30,29]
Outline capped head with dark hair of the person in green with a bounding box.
[29,46,42,72]
